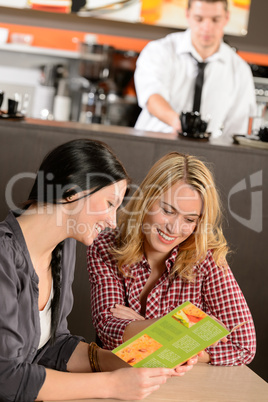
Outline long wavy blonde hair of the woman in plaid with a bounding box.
[112,152,228,280]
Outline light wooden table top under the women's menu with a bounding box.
[44,363,268,402]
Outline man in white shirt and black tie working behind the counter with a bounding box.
[135,0,256,137]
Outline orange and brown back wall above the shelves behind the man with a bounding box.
[0,0,268,65]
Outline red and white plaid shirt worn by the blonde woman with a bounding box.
[87,231,256,366]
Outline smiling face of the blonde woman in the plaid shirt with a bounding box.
[143,181,202,260]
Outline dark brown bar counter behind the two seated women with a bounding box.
[0,120,268,380]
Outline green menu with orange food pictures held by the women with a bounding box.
[113,301,230,368]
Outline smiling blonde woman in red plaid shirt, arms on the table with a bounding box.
[88,152,256,365]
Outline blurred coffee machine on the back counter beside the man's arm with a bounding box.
[79,43,140,126]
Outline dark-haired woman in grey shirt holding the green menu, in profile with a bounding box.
[0,140,195,402]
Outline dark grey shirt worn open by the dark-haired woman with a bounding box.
[0,212,82,402]
